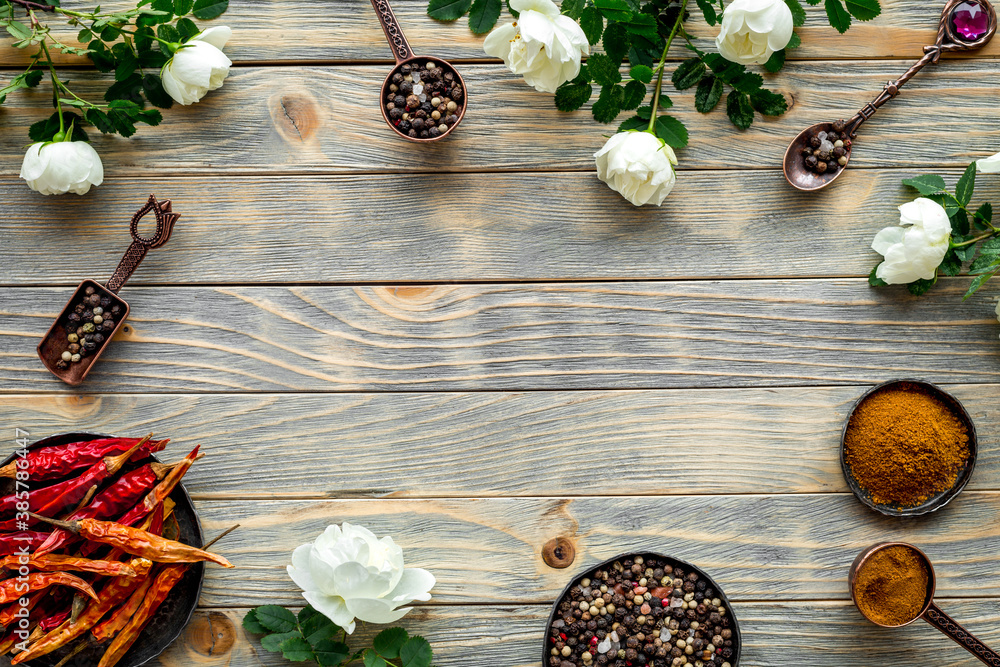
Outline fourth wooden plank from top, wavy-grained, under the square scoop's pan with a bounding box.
[0,280,1000,393]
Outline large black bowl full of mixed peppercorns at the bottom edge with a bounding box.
[542,553,742,667]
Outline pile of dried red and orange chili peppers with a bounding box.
[0,435,233,667]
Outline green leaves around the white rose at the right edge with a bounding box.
[869,163,1000,299]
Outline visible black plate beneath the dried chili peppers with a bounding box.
[0,433,205,667]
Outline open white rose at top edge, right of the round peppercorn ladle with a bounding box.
[483,0,590,93]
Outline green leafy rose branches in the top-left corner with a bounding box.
[0,0,229,142]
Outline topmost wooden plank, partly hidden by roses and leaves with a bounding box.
[0,0,1000,66]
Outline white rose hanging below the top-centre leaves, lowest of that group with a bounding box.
[594,130,677,206]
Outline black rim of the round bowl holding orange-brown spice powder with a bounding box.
[840,379,979,516]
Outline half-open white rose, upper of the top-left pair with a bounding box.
[160,26,233,105]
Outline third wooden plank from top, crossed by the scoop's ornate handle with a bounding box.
[0,170,984,286]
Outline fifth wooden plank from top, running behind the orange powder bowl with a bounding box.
[0,385,1000,500]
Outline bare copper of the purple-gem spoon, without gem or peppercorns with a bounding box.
[784,0,997,192]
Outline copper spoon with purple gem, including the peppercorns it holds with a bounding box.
[784,0,997,192]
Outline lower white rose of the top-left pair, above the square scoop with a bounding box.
[21,141,104,195]
